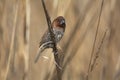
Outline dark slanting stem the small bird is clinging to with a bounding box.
[42,0,62,80]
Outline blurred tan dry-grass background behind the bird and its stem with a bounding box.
[0,0,120,80]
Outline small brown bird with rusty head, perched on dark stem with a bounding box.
[35,16,66,63]
